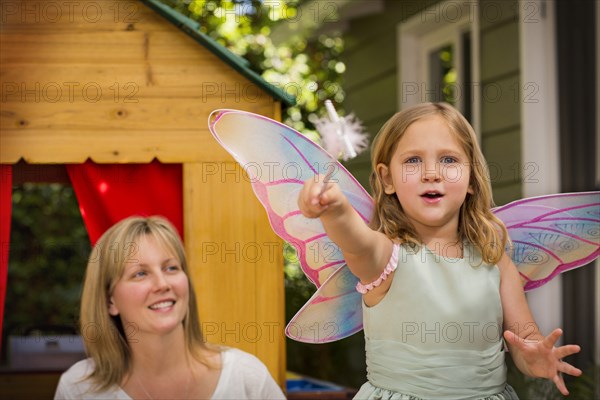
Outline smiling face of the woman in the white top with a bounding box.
[109,235,189,340]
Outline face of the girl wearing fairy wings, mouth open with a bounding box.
[377,116,473,239]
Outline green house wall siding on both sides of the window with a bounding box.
[343,0,527,204]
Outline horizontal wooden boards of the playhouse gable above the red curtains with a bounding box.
[0,1,277,163]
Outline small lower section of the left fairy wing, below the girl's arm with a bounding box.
[285,265,363,344]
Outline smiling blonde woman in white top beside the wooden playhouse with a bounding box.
[55,217,285,399]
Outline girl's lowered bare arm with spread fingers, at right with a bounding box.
[498,254,581,396]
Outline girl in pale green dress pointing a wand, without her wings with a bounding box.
[298,103,581,400]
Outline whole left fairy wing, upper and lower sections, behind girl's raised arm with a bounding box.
[209,110,373,343]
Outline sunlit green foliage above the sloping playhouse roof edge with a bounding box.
[161,0,345,139]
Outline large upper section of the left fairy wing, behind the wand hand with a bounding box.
[209,110,373,287]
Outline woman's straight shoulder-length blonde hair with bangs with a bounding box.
[80,217,212,391]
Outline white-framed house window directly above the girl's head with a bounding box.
[398,1,479,126]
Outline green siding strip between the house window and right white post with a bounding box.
[479,1,527,205]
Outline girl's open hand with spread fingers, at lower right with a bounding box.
[504,329,581,396]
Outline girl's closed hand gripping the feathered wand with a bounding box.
[298,175,345,218]
